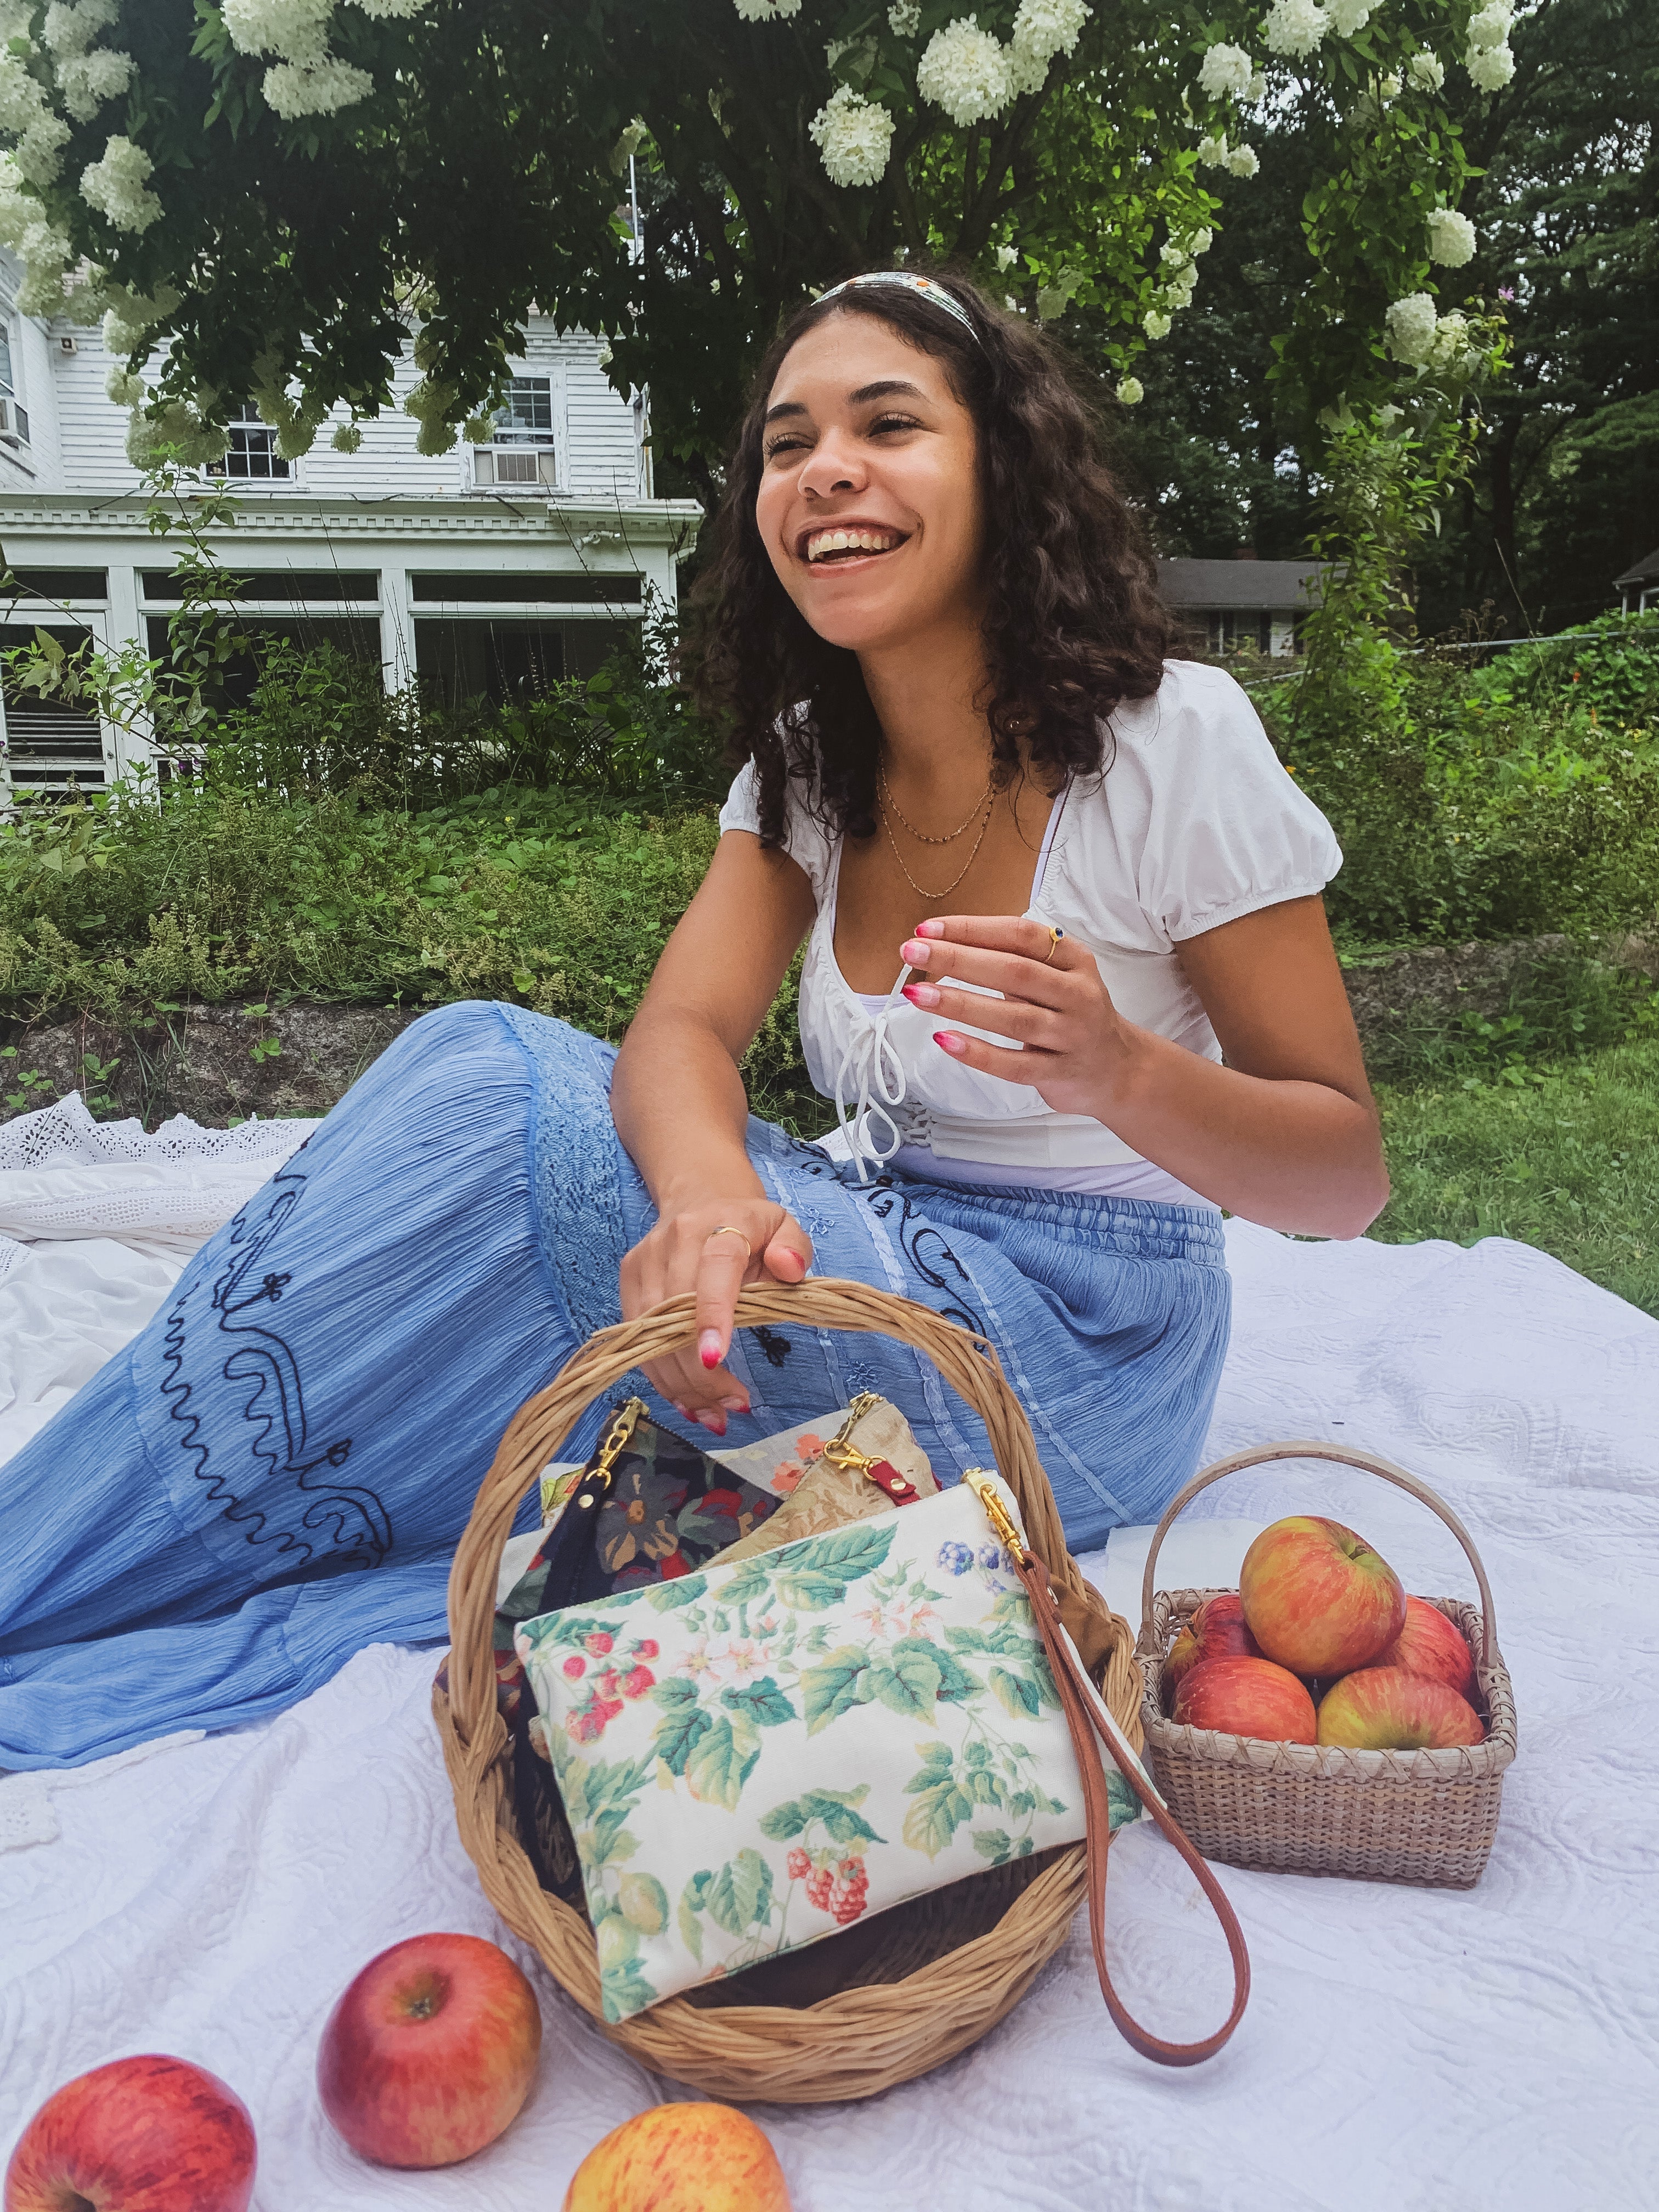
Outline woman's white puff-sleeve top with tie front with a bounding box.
[721,662,1342,1197]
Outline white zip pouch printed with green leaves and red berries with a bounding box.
[517,1482,1139,2022]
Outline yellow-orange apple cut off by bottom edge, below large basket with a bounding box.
[560,2103,789,2212]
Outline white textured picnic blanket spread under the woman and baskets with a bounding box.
[0,1106,1659,2212]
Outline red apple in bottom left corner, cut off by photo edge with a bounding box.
[4,2053,257,2212]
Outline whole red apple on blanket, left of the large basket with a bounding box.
[317,1936,542,2168]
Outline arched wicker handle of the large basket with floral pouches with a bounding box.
[449,1276,1106,1756]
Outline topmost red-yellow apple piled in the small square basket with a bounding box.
[1239,1513,1404,1674]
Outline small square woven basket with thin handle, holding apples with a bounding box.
[1137,1442,1515,1889]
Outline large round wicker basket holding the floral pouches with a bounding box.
[433,1281,1142,2103]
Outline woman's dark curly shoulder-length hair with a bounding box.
[688,272,1170,845]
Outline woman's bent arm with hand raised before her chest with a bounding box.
[905,898,1389,1237]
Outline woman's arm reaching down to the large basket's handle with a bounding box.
[611,830,814,1434]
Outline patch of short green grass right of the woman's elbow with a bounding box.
[1372,1037,1659,1316]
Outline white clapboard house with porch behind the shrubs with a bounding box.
[0,252,701,803]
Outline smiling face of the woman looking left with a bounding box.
[754,314,984,654]
